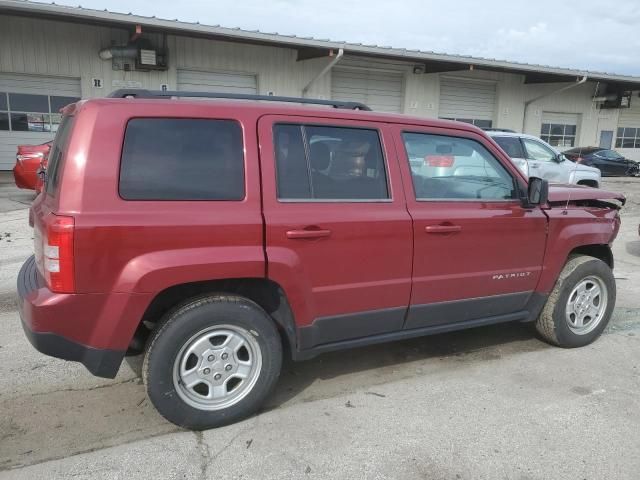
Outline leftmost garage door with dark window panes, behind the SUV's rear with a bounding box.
[0,73,80,170]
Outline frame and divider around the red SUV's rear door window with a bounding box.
[271,121,394,203]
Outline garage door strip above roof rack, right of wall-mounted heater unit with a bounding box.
[178,70,258,94]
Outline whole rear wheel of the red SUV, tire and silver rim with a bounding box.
[142,295,282,430]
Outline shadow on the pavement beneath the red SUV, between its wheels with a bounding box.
[263,323,551,411]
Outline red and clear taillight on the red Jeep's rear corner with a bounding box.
[42,215,75,293]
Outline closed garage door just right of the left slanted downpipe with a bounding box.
[331,68,403,113]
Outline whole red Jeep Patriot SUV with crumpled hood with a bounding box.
[17,90,625,429]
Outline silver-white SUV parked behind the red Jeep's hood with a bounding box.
[487,131,602,188]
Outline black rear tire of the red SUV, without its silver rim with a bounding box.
[142,294,282,430]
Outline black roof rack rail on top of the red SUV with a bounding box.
[107,88,371,111]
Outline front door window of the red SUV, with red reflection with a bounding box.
[402,132,517,201]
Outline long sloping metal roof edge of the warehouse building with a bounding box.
[0,0,640,90]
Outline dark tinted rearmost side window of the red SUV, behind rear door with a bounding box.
[119,118,245,200]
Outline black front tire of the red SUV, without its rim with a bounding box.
[535,255,616,348]
